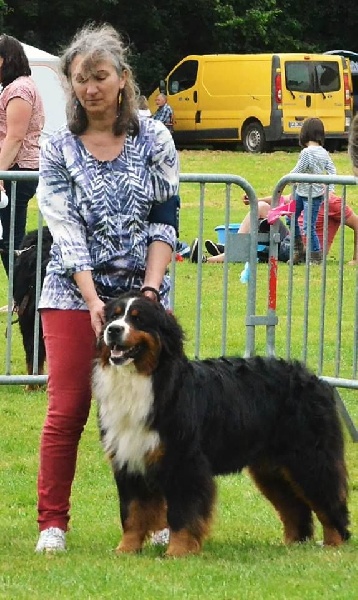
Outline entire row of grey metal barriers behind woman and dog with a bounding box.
[0,172,358,441]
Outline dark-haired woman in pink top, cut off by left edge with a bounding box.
[0,34,45,274]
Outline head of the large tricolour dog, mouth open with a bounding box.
[99,293,179,375]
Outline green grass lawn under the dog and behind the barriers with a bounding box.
[0,151,358,600]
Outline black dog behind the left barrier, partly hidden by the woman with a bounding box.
[13,227,52,375]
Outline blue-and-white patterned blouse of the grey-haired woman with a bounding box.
[37,118,179,310]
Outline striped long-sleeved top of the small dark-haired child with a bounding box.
[291,146,336,198]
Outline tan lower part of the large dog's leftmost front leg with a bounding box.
[116,498,167,554]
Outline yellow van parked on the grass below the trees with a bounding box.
[149,53,352,152]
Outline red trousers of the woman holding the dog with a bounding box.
[38,309,96,531]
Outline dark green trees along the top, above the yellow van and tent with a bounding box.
[0,0,358,94]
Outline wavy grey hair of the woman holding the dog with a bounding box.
[60,24,138,135]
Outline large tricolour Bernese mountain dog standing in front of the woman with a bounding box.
[93,292,350,557]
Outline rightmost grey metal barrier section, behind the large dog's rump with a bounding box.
[267,174,358,442]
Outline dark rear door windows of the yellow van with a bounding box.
[285,61,340,94]
